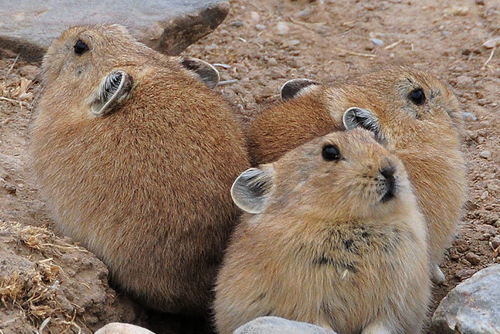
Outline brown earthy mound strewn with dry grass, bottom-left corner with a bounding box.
[0,220,137,334]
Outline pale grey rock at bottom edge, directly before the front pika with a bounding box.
[233,317,336,334]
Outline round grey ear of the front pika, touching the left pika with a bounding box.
[231,167,273,214]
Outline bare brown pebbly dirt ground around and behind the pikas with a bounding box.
[0,0,500,334]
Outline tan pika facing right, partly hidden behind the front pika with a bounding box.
[246,65,467,282]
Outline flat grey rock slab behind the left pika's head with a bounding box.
[0,0,229,61]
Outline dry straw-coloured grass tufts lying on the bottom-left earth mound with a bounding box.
[0,221,89,333]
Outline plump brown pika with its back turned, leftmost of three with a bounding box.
[30,25,250,314]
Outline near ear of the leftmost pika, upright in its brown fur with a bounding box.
[90,70,133,117]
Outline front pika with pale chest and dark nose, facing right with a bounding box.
[214,129,430,334]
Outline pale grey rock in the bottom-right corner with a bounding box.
[432,265,500,334]
